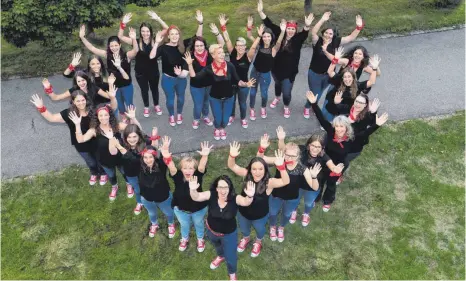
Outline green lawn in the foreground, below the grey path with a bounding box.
[1,112,465,280]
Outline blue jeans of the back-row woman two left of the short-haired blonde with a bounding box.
[162,74,188,116]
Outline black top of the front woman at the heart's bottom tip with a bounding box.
[207,190,238,234]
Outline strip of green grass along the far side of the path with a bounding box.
[1,0,465,79]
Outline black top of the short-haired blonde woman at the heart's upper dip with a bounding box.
[191,62,240,99]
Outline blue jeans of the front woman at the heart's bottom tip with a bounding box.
[207,229,238,274]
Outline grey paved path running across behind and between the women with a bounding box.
[1,29,465,178]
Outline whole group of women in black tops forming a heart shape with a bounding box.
[31,0,388,280]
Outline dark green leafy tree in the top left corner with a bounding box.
[2,0,163,47]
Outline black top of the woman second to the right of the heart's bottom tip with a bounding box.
[272,162,306,200]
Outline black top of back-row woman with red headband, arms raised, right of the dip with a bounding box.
[262,17,309,81]
